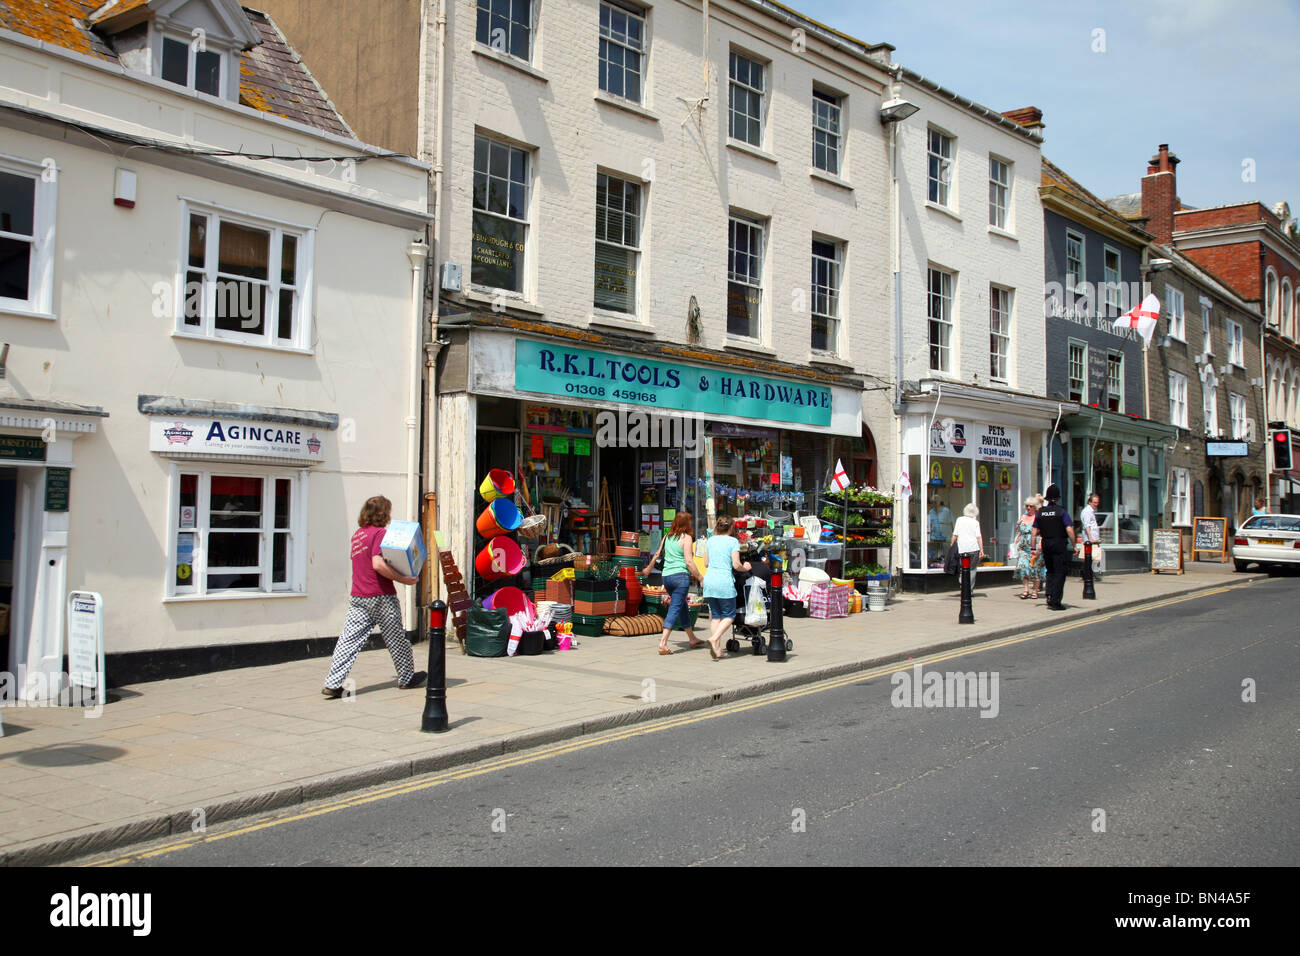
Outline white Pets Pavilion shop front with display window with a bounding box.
[898,381,1078,591]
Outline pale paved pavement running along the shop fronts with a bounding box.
[0,563,1266,866]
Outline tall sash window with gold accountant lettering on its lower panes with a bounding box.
[469,135,529,293]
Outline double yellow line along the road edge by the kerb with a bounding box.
[94,581,1251,866]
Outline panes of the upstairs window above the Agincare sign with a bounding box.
[177,202,312,349]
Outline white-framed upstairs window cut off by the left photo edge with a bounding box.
[0,159,57,315]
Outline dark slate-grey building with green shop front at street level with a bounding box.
[1039,159,1177,571]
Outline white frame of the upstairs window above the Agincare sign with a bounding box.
[173,196,316,351]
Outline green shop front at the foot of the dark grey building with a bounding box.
[1049,406,1178,571]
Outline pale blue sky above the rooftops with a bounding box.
[785,0,1300,217]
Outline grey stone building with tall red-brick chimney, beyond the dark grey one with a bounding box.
[1108,144,1268,546]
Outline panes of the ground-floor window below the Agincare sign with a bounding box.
[168,468,304,597]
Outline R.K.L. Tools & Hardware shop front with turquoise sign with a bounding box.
[438,328,875,590]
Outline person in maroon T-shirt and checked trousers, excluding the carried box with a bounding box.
[321,494,428,698]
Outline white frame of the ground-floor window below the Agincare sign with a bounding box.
[163,460,308,601]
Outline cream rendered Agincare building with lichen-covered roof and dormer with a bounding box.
[0,0,428,688]
